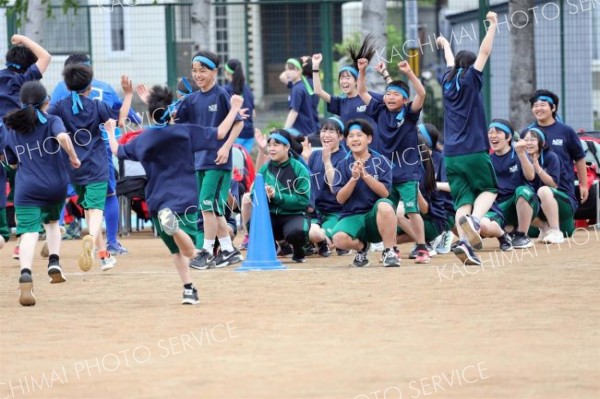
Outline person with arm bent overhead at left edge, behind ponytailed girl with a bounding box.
[0,35,51,259]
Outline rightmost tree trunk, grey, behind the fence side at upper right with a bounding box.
[508,0,536,131]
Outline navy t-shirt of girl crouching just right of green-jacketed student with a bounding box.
[308,148,346,213]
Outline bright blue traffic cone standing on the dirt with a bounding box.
[236,174,287,272]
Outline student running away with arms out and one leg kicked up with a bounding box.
[105,86,243,305]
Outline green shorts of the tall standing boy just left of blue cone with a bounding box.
[196,169,231,216]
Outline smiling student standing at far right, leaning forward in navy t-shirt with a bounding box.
[521,90,589,236]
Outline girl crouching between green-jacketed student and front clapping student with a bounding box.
[308,117,347,257]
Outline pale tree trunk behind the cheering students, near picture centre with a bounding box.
[361,0,386,92]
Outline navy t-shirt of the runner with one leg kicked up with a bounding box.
[117,124,218,215]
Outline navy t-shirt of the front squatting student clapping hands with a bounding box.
[333,150,392,219]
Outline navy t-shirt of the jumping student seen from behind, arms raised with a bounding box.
[442,66,489,156]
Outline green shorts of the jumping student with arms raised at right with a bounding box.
[444,151,498,210]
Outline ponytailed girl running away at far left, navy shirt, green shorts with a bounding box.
[4,82,81,306]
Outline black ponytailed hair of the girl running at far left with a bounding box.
[4,81,48,134]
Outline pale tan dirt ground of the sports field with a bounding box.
[0,230,600,399]
